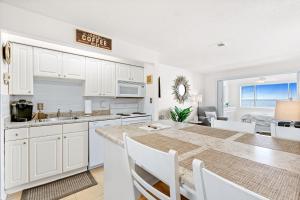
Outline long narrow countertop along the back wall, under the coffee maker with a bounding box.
[5,114,151,130]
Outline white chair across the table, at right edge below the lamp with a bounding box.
[271,123,300,141]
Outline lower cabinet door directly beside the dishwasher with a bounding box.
[63,131,88,172]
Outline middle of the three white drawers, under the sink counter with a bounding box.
[29,125,62,138]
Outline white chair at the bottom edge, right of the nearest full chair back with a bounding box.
[193,159,267,200]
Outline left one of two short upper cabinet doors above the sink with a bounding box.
[33,48,62,78]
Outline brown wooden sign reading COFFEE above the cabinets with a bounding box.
[76,29,112,50]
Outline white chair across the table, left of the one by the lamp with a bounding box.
[211,118,256,134]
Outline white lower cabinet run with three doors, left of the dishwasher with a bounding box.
[4,122,88,192]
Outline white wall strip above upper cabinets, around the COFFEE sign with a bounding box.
[0,3,159,63]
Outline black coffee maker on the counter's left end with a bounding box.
[10,99,33,122]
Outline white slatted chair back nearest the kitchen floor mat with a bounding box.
[123,133,180,200]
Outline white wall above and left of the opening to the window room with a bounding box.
[204,58,300,106]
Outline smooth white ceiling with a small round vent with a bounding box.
[3,0,300,73]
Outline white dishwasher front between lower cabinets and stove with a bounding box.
[89,119,121,169]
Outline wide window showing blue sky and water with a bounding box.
[241,83,297,107]
